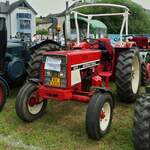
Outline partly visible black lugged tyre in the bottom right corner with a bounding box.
[133,95,150,150]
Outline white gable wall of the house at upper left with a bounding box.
[10,7,36,38]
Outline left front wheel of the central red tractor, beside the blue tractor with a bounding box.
[16,82,47,122]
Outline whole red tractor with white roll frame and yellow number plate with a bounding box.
[16,4,140,140]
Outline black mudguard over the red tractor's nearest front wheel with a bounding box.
[95,87,115,108]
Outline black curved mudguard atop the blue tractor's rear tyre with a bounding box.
[30,39,61,50]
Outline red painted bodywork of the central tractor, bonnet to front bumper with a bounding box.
[37,38,135,102]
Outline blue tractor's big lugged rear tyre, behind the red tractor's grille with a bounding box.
[27,43,60,78]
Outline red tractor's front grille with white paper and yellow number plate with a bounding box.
[43,55,67,88]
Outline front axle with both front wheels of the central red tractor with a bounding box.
[16,79,114,140]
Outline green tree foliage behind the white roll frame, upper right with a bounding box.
[81,0,150,34]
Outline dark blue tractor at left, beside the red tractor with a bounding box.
[0,17,61,111]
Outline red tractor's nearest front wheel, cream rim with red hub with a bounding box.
[86,93,113,140]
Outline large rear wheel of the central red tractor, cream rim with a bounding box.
[116,48,141,102]
